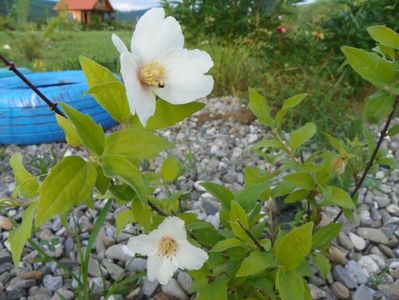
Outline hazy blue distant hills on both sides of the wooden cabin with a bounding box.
[0,0,147,22]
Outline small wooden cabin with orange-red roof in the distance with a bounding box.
[54,0,114,24]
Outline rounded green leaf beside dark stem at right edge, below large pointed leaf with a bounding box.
[364,90,395,124]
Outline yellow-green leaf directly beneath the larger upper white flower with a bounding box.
[146,100,205,130]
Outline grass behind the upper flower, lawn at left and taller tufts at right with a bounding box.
[0,31,363,138]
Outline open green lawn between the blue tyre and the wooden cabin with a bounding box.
[0,31,131,71]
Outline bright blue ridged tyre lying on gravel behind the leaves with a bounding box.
[0,71,116,145]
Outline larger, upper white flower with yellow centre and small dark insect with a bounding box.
[112,8,213,126]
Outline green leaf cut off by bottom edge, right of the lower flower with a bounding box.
[276,269,305,300]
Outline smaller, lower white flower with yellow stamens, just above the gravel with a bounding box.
[123,217,208,284]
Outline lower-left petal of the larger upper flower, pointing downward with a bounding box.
[121,53,156,127]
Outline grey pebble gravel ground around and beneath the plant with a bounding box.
[0,97,399,300]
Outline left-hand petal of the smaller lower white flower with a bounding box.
[127,230,161,255]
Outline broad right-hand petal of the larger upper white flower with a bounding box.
[155,49,214,104]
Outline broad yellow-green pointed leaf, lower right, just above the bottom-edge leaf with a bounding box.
[274,222,313,270]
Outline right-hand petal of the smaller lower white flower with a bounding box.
[176,240,208,270]
